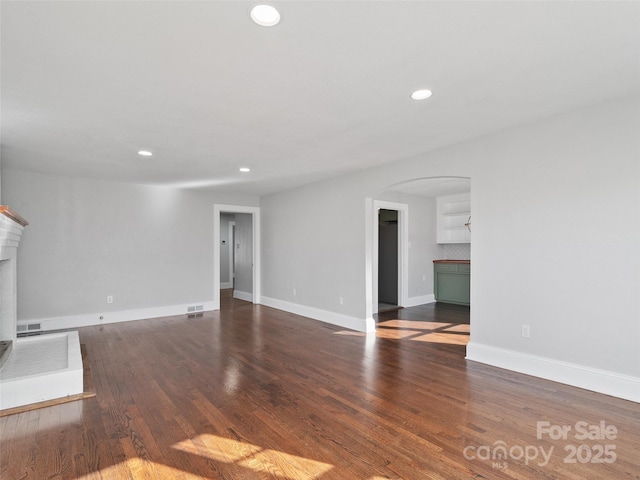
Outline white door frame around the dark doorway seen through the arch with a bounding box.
[366,199,409,318]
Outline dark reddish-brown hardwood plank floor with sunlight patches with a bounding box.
[0,298,640,480]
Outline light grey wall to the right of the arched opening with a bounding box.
[468,97,640,401]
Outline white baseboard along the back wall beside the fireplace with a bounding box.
[18,301,213,333]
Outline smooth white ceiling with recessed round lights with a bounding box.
[1,1,640,195]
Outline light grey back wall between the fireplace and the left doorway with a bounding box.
[2,169,258,326]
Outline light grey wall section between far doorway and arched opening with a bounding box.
[260,172,365,329]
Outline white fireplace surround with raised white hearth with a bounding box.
[0,206,83,410]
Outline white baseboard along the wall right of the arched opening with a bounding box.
[466,341,640,403]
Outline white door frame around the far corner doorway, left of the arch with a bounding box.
[213,204,260,310]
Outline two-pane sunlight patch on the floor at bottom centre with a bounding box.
[173,434,333,480]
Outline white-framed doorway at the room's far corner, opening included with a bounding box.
[213,205,260,310]
